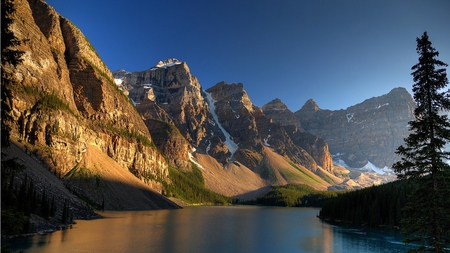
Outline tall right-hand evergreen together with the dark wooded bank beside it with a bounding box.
[320,32,450,252]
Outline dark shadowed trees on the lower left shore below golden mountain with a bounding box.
[1,159,70,235]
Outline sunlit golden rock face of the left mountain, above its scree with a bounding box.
[2,0,176,208]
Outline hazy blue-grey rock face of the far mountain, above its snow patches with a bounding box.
[295,88,415,168]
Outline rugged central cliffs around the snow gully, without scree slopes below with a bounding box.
[118,63,332,188]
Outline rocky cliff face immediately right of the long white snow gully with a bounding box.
[206,82,328,171]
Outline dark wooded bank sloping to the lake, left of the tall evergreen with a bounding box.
[319,180,414,227]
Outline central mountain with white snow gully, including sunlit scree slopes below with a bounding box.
[117,59,342,196]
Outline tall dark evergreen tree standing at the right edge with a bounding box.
[393,32,450,252]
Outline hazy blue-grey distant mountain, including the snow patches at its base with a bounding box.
[263,88,415,190]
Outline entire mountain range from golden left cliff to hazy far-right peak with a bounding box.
[2,0,415,217]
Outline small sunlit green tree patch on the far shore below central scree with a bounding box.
[246,184,341,207]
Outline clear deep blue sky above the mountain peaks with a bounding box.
[47,0,450,111]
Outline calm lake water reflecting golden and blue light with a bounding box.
[4,206,412,253]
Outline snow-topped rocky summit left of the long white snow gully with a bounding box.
[123,59,209,146]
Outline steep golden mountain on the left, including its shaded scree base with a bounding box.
[2,0,178,214]
